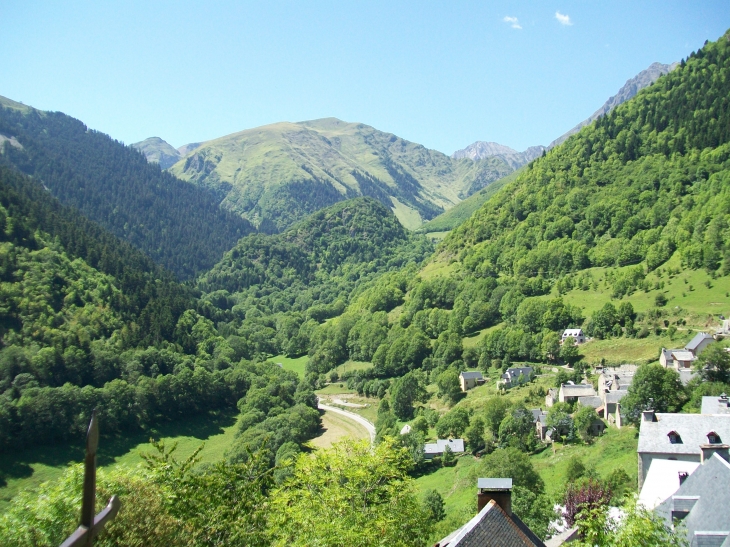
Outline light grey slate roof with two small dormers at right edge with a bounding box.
[636,413,730,455]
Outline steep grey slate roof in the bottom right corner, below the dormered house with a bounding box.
[656,454,730,545]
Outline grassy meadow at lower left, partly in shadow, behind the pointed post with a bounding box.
[0,413,236,512]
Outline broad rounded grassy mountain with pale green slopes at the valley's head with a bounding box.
[170,118,511,231]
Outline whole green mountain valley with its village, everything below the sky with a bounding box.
[0,23,730,547]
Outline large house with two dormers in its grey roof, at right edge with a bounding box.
[637,410,730,490]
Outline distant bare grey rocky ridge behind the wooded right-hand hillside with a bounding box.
[451,63,679,163]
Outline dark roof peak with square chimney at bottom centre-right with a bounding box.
[434,479,545,547]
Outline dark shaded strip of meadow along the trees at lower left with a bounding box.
[0,411,237,487]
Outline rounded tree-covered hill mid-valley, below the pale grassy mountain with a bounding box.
[198,198,433,364]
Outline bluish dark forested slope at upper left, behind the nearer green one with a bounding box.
[0,100,254,279]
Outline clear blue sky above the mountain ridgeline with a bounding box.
[0,0,730,154]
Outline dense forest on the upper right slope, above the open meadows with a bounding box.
[443,35,730,278]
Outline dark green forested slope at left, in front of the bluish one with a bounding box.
[0,166,319,460]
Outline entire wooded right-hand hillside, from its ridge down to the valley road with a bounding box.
[272,30,730,388]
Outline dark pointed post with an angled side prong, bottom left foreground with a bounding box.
[61,409,122,547]
